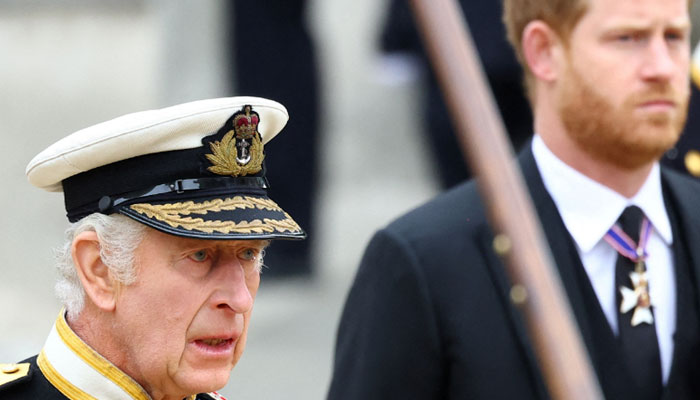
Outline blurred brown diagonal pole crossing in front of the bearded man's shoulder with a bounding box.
[411,0,603,400]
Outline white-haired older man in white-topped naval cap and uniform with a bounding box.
[0,97,305,400]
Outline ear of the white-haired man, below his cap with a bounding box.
[71,231,118,311]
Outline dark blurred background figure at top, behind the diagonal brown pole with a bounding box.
[379,0,532,188]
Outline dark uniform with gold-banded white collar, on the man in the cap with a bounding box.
[0,311,225,400]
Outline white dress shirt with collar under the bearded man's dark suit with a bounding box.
[532,135,676,384]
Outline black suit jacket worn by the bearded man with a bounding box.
[328,146,700,400]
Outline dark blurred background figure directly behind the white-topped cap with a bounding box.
[226,0,322,279]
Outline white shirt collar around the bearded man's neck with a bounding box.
[532,134,673,253]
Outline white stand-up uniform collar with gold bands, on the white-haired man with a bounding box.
[37,310,200,400]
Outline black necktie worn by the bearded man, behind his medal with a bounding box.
[615,206,662,400]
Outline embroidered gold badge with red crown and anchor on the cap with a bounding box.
[206,105,265,176]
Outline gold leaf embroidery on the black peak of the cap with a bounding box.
[129,196,301,234]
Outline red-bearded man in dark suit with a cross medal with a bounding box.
[328,0,700,400]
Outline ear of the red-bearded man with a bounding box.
[522,20,561,82]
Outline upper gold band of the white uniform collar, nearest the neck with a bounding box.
[55,311,151,400]
